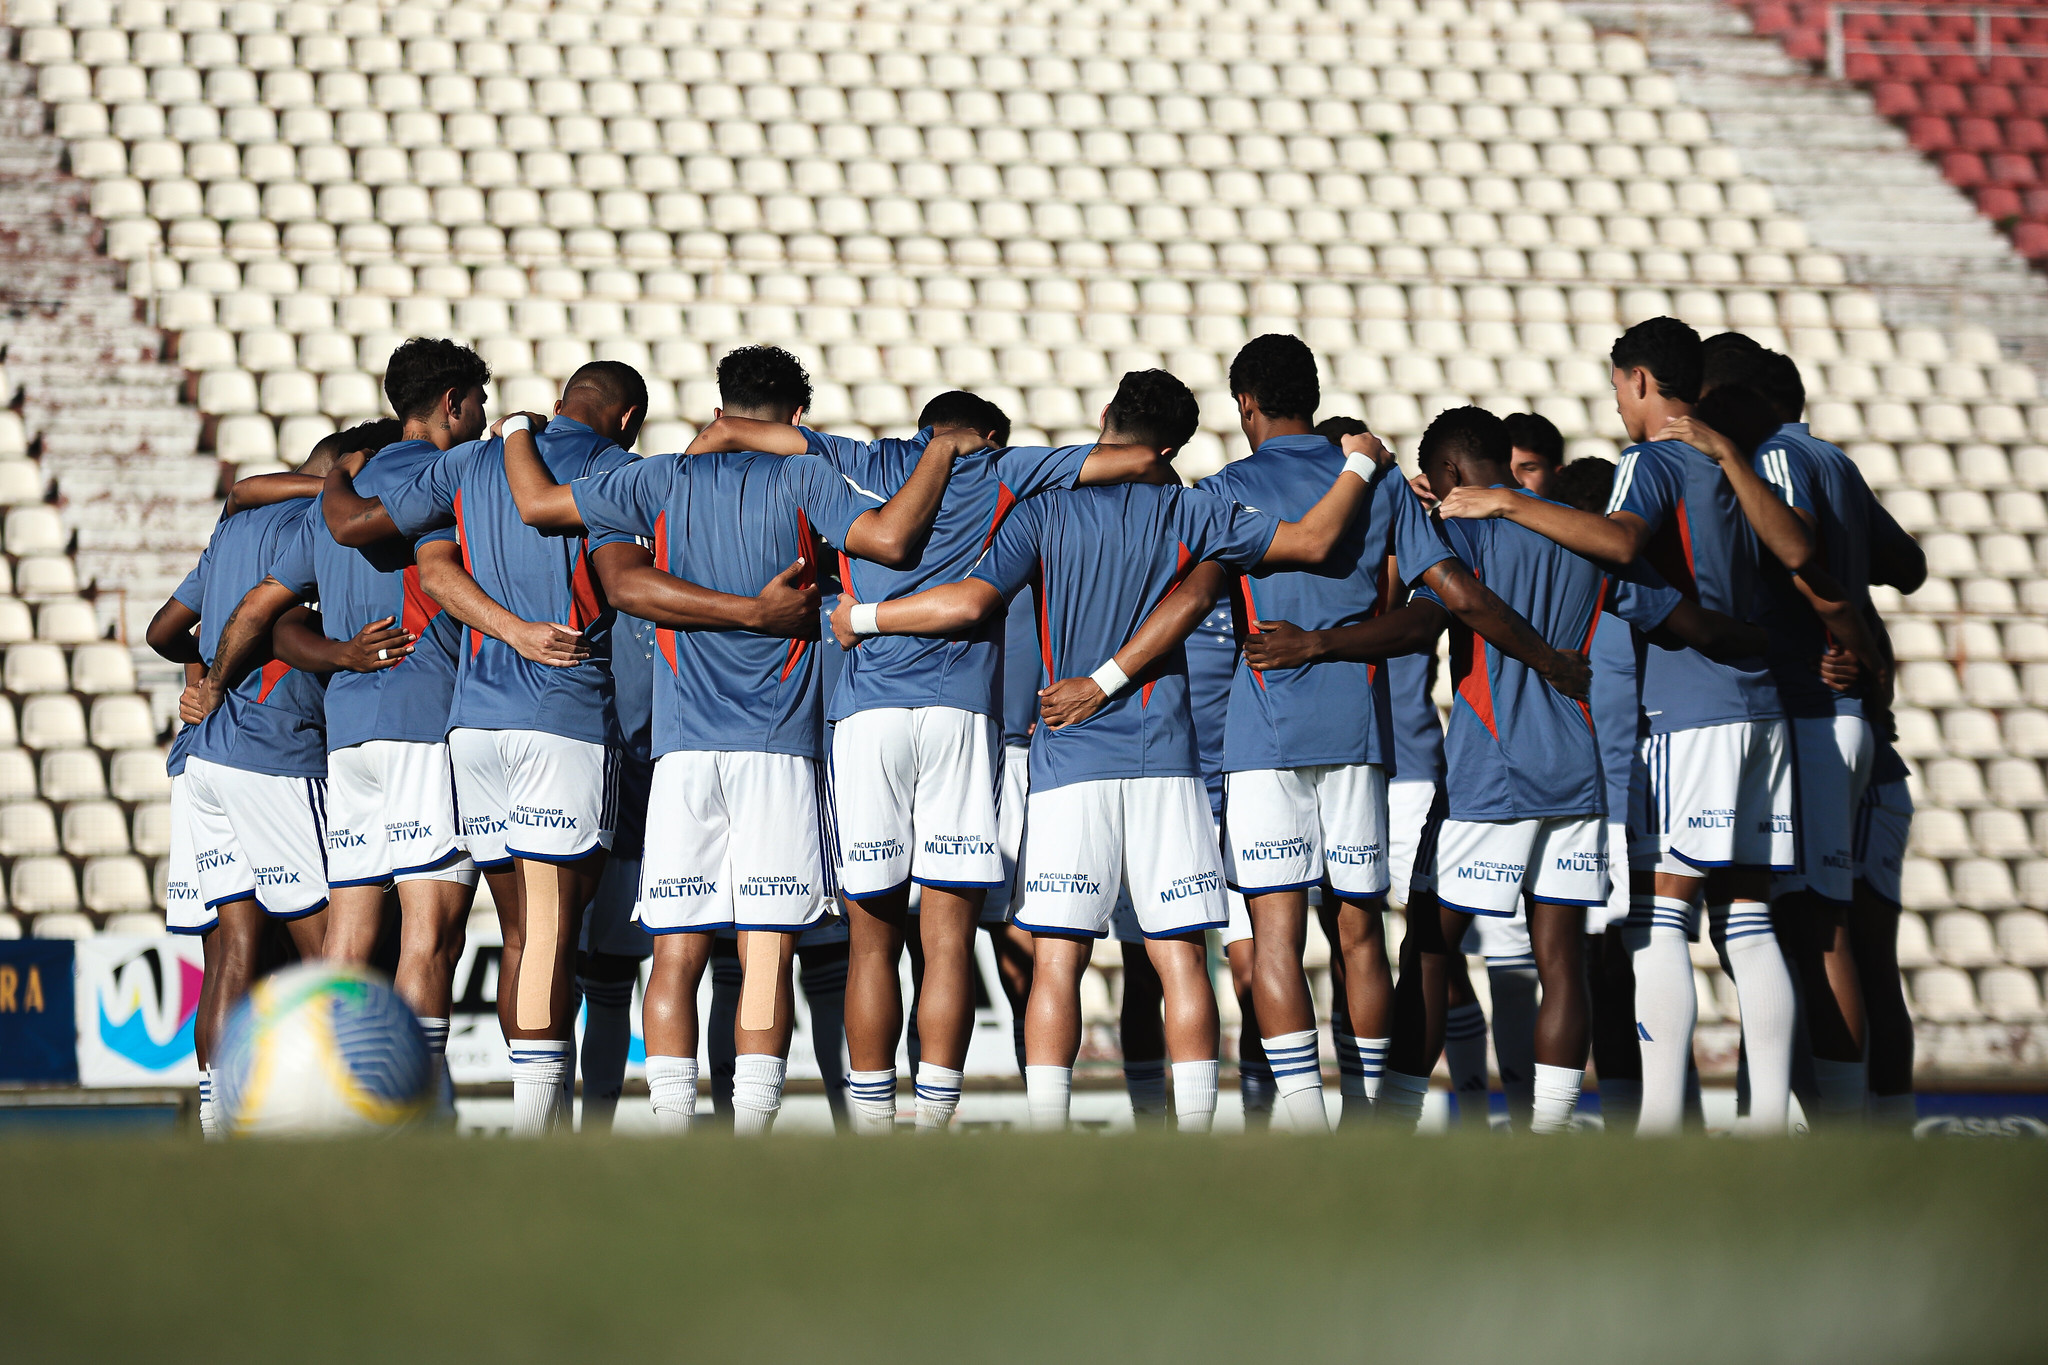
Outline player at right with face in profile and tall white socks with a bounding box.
[1442,317,1796,1136]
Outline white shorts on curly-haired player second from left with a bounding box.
[325,739,477,886]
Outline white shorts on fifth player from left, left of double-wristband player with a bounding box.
[831,706,1004,900]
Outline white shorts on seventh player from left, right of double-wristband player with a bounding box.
[1223,763,1386,900]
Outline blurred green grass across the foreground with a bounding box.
[0,1136,2048,1365]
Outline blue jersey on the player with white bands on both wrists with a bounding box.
[975,483,1280,792]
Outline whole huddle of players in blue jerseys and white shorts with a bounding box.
[150,317,1925,1134]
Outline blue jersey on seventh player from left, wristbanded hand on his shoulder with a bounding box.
[1200,436,1450,772]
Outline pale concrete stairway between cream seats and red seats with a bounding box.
[1571,0,2048,368]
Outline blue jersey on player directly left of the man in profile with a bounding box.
[1423,497,1679,821]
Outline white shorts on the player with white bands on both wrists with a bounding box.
[1016,778,1229,939]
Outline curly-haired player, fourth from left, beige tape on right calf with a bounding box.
[504,346,981,1134]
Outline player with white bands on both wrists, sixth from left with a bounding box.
[831,370,1376,1130]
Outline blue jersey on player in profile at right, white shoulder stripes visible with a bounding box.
[1608,440,1784,735]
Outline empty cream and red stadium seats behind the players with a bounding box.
[0,0,2048,1047]
